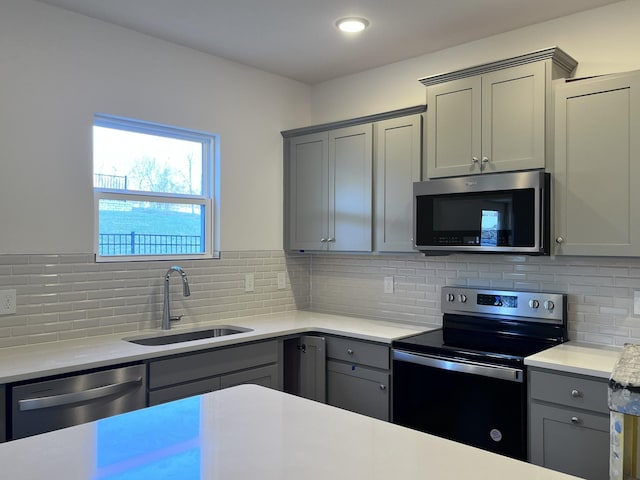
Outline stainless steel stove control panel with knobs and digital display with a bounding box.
[441,287,567,323]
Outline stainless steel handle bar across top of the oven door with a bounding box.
[393,350,524,383]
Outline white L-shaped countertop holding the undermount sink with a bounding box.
[0,310,436,384]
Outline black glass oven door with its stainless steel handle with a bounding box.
[392,350,527,460]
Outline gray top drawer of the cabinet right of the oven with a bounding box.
[529,370,609,414]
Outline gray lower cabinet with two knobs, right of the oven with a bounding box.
[529,369,609,480]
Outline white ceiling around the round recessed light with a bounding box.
[39,0,620,85]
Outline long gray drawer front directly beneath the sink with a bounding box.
[149,342,278,390]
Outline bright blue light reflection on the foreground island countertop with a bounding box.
[94,396,201,480]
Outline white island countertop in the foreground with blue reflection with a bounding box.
[0,385,576,480]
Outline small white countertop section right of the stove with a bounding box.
[524,342,622,379]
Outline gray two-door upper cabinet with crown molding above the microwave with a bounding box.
[421,48,577,178]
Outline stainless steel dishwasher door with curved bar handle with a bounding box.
[10,364,146,439]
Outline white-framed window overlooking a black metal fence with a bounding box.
[93,115,218,261]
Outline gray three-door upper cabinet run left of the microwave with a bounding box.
[282,105,425,252]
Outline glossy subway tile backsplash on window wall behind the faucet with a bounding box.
[0,251,311,348]
